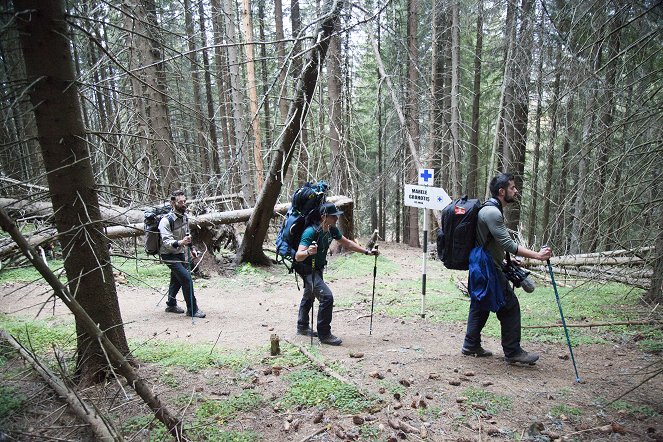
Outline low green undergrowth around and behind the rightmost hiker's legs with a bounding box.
[336,257,663,353]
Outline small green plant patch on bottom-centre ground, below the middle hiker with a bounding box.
[280,369,376,413]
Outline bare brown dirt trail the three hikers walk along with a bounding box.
[0,244,663,440]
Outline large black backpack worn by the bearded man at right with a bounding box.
[437,195,496,270]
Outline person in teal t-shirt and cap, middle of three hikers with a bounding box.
[295,203,379,345]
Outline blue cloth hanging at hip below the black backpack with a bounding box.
[467,246,505,312]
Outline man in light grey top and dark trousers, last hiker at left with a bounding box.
[159,190,205,318]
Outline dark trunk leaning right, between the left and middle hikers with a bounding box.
[236,0,343,265]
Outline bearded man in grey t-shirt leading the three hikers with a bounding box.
[461,173,552,364]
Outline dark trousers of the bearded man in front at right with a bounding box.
[463,270,522,358]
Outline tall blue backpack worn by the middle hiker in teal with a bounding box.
[276,181,329,273]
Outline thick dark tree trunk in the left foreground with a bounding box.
[14,0,129,384]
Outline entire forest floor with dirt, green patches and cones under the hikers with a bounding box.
[0,243,663,441]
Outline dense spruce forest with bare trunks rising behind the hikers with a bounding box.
[0,0,663,440]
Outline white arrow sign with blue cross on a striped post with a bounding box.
[403,169,451,318]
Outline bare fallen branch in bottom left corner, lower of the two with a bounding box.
[0,330,122,441]
